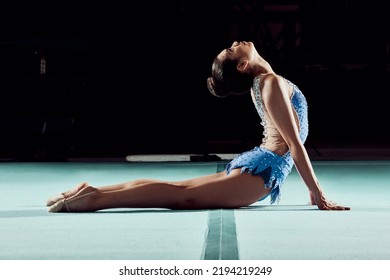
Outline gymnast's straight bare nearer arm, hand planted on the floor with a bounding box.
[261,74,349,210]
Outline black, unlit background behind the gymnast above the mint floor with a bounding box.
[0,0,390,161]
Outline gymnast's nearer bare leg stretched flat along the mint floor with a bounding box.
[48,169,269,212]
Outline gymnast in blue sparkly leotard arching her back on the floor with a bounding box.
[46,41,350,212]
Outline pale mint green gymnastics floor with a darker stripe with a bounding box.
[0,161,390,260]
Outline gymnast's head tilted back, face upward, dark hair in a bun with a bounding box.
[207,42,253,97]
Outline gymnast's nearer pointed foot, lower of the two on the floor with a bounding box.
[48,186,97,212]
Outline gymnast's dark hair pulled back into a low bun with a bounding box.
[207,57,253,97]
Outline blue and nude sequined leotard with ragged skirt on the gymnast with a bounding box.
[226,76,309,204]
